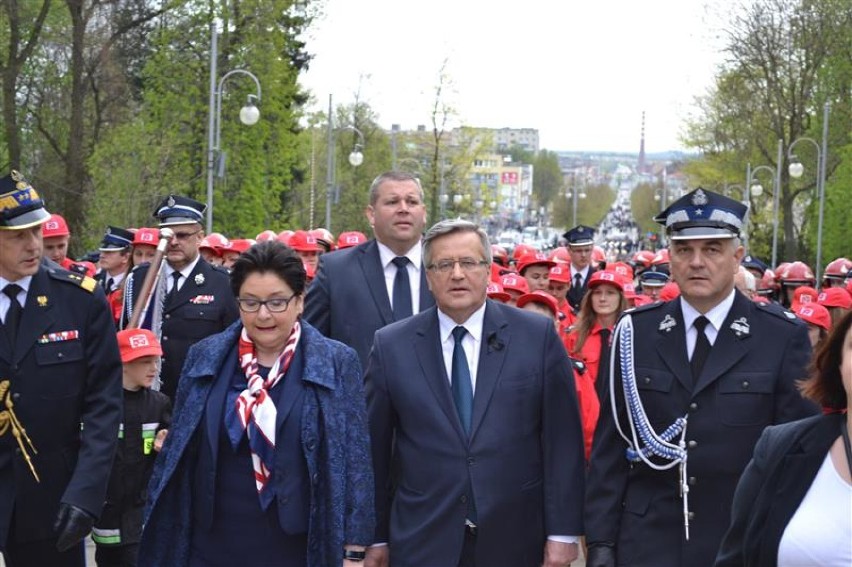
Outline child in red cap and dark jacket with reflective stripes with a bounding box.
[92,329,172,567]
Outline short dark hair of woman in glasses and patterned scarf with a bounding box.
[231,240,307,297]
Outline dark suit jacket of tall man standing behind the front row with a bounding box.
[304,240,435,366]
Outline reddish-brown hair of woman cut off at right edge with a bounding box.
[799,313,852,410]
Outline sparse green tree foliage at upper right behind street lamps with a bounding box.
[686,0,852,266]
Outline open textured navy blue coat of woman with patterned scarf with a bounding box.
[139,322,375,567]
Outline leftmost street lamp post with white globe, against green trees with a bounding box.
[206,23,261,234]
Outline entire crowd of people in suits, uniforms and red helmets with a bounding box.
[0,171,852,567]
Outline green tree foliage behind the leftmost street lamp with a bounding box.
[88,0,310,250]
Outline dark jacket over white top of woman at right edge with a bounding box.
[716,414,846,567]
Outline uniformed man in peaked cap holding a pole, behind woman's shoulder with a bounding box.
[121,195,239,399]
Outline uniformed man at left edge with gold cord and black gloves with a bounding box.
[0,171,121,567]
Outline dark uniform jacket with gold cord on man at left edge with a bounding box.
[0,264,122,547]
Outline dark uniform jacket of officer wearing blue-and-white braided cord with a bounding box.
[585,292,818,567]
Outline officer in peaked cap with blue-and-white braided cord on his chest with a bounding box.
[585,188,817,567]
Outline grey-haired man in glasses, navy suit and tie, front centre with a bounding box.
[365,220,585,567]
